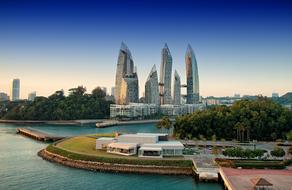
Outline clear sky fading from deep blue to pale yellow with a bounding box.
[0,0,292,98]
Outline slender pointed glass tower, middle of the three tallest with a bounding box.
[159,44,172,104]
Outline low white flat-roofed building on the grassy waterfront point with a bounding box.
[96,133,184,158]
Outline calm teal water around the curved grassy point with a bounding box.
[0,124,223,190]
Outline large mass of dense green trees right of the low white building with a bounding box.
[174,97,292,141]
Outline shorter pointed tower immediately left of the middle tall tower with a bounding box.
[145,65,160,105]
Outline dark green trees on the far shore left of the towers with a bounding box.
[0,86,112,120]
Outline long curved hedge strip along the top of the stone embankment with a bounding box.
[46,144,192,167]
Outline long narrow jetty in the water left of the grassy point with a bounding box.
[16,128,65,142]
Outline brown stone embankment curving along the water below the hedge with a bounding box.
[38,149,193,175]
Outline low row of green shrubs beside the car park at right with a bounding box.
[223,147,265,158]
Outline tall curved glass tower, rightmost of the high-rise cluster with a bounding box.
[185,45,200,104]
